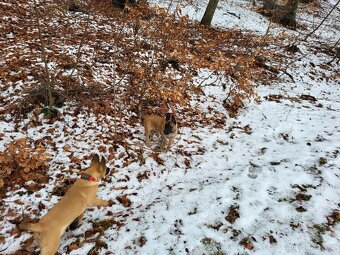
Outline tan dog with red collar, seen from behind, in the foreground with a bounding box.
[19,155,109,255]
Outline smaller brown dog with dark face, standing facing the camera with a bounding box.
[144,113,178,150]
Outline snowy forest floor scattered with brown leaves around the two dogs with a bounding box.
[0,1,340,255]
